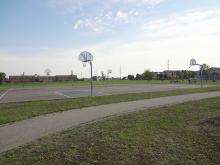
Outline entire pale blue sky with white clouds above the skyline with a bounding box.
[0,0,220,77]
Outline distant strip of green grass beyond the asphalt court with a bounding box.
[0,80,220,90]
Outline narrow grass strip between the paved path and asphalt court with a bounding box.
[0,87,220,125]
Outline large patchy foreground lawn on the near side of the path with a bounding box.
[0,98,220,165]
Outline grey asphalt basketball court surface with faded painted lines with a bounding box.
[0,84,213,103]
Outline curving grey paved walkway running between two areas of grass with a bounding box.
[0,91,220,152]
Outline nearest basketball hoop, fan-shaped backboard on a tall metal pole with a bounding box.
[79,51,93,97]
